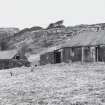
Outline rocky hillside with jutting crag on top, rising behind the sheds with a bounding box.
[1,20,105,53]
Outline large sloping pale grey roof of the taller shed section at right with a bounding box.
[61,31,105,47]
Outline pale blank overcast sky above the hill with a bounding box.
[0,0,105,29]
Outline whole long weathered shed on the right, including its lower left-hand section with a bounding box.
[40,30,105,65]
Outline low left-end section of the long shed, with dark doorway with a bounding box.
[40,46,62,65]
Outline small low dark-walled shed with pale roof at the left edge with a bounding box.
[0,49,30,69]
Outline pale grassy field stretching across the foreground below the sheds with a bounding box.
[0,63,105,105]
